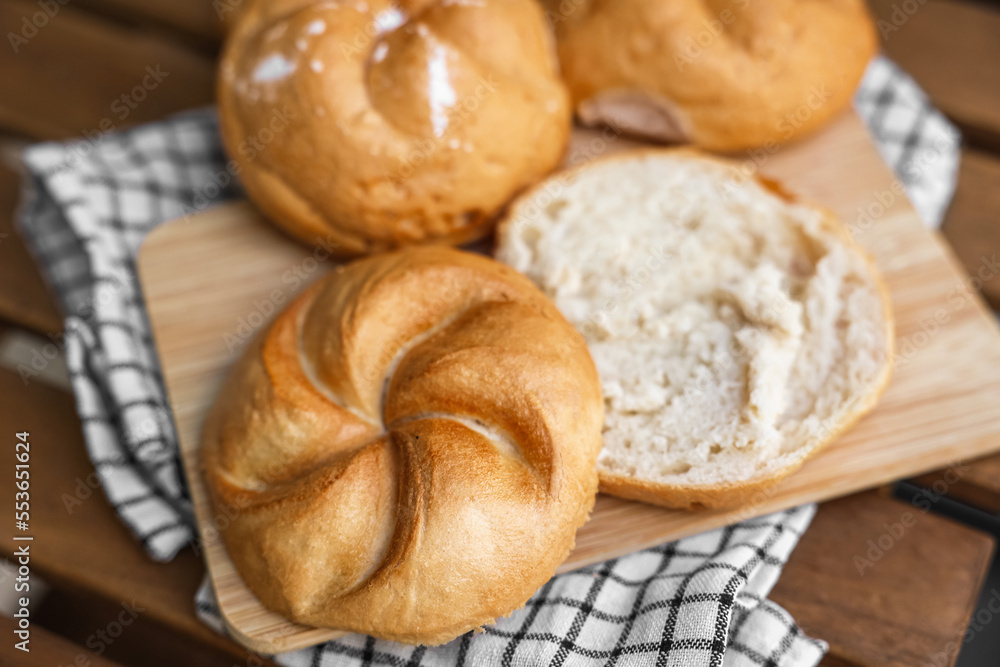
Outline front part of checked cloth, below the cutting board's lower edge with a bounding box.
[197,505,826,667]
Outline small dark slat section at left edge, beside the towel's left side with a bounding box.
[0,164,62,334]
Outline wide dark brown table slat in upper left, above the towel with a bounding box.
[0,0,214,139]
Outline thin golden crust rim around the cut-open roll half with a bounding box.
[497,147,895,510]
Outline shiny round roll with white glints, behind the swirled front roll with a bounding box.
[218,0,571,255]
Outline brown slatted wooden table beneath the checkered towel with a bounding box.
[0,0,1000,667]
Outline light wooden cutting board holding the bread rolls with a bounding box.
[139,113,1000,653]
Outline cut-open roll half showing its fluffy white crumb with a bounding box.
[497,149,893,508]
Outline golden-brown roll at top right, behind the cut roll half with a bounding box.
[543,0,876,151]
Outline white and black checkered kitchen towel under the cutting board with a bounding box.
[20,59,959,666]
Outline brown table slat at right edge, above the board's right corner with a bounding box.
[942,149,1000,308]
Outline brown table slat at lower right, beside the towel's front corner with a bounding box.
[770,493,993,667]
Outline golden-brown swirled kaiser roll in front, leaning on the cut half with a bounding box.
[202,248,603,644]
